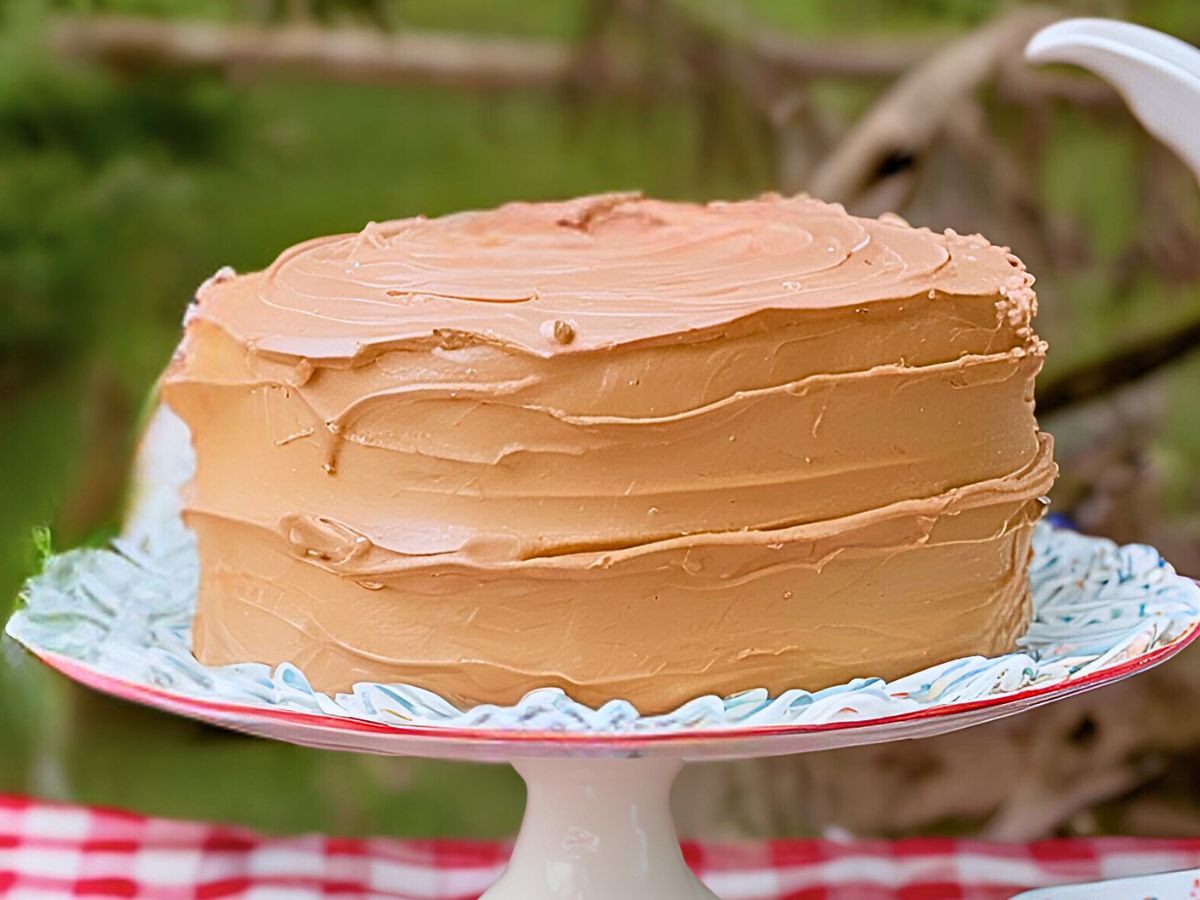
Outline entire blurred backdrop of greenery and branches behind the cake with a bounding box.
[0,0,1200,839]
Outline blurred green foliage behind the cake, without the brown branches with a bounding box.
[0,0,1200,836]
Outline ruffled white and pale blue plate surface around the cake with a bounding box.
[7,414,1200,734]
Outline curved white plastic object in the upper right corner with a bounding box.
[1025,19,1200,179]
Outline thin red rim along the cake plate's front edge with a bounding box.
[34,620,1200,746]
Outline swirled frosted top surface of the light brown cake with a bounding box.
[193,193,1032,359]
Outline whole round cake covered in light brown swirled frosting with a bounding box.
[162,194,1056,713]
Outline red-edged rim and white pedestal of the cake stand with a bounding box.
[34,622,1200,900]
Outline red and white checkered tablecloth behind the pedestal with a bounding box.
[0,796,1200,900]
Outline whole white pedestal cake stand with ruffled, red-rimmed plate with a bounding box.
[6,412,1200,900]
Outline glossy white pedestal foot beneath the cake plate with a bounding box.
[482,758,716,900]
